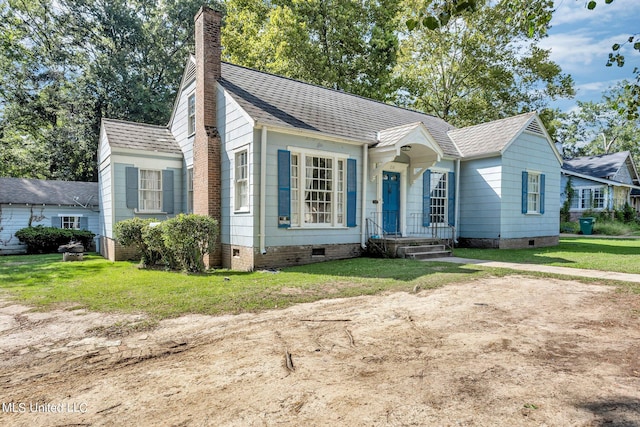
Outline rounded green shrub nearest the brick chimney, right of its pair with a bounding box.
[162,214,218,272]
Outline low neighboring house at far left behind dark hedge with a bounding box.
[0,178,99,255]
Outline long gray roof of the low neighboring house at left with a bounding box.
[0,178,98,206]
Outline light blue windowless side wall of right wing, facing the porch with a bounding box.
[458,157,504,239]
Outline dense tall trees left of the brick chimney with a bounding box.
[0,0,220,180]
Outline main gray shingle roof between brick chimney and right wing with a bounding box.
[220,62,459,157]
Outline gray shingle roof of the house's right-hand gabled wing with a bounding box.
[449,112,536,157]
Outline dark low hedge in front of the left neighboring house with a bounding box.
[16,225,95,254]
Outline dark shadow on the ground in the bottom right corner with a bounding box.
[578,396,640,427]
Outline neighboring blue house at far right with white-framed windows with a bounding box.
[561,151,640,220]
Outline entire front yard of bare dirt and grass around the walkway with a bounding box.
[0,239,640,426]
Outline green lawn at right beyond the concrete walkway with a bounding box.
[454,237,640,274]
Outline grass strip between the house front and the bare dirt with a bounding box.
[0,254,500,320]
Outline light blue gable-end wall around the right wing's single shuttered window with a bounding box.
[500,132,561,239]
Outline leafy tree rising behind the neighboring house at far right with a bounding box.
[558,81,640,163]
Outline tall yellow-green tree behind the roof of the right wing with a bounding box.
[396,0,573,126]
